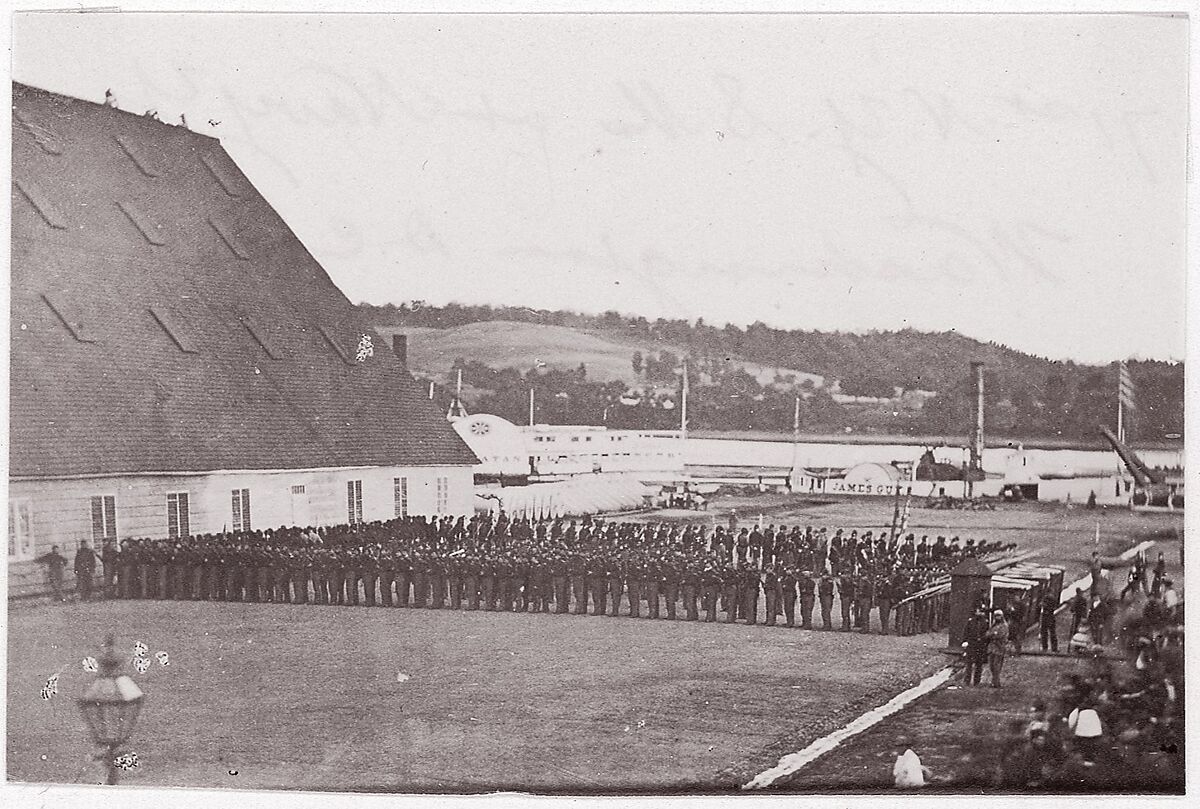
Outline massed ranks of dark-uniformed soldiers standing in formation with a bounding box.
[43,515,1013,633]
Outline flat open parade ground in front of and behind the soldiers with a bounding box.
[7,497,1182,792]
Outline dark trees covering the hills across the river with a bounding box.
[361,301,1184,441]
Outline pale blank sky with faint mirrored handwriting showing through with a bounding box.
[13,13,1188,361]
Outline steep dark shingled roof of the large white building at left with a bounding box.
[10,84,476,478]
